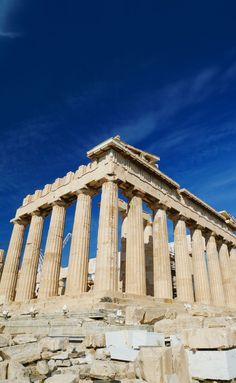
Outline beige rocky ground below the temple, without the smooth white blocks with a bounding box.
[0,302,236,383]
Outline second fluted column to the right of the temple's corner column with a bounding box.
[153,207,173,299]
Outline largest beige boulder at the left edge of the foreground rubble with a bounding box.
[1,343,41,364]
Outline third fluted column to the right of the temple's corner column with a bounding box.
[174,217,194,302]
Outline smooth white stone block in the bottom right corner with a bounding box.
[187,349,236,381]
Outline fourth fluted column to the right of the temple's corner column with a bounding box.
[192,226,211,304]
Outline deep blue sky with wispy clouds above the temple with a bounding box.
[0,0,236,264]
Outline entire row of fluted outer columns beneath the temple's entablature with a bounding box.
[0,181,236,306]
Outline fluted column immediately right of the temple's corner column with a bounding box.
[125,194,146,295]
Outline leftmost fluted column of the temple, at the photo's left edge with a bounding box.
[0,221,25,301]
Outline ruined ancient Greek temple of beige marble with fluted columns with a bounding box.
[0,136,236,307]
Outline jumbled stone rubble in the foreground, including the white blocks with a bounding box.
[0,303,236,383]
